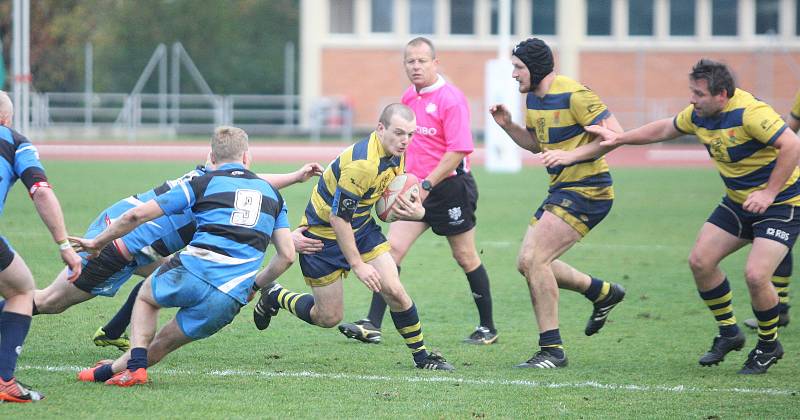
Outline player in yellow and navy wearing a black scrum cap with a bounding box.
[490,38,625,369]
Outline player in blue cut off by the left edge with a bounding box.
[0,91,81,403]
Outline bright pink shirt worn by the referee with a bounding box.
[402,75,475,180]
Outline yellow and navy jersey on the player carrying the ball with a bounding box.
[300,132,405,239]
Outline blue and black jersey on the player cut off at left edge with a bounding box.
[0,125,47,214]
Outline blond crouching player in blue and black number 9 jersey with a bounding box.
[70,127,295,386]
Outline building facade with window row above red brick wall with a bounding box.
[300,0,800,131]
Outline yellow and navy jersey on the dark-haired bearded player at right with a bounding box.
[673,89,800,205]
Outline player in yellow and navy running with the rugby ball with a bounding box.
[253,104,453,370]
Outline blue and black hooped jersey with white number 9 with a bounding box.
[155,164,289,304]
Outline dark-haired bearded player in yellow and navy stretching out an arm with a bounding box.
[586,59,800,374]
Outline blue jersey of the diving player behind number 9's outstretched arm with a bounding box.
[111,166,206,264]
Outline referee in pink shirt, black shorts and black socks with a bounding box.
[339,37,497,344]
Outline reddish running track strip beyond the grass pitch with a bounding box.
[36,143,712,167]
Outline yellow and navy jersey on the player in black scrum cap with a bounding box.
[525,75,614,200]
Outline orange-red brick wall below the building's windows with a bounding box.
[320,48,800,130]
